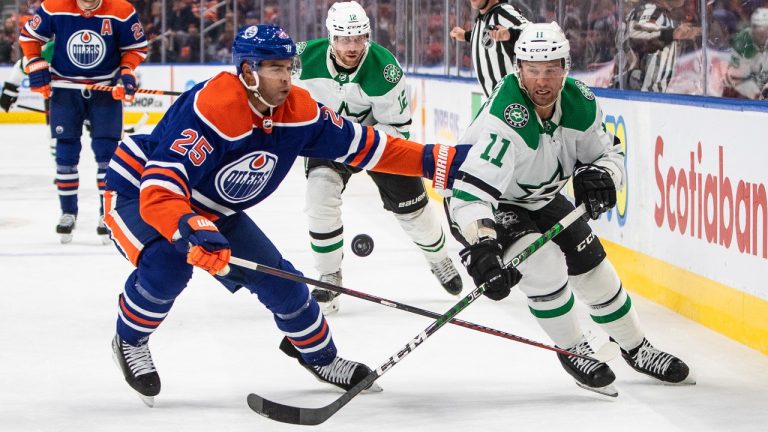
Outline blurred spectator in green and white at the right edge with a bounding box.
[726,7,768,99]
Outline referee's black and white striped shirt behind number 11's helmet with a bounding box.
[464,2,528,97]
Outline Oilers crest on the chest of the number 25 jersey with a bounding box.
[216,151,277,204]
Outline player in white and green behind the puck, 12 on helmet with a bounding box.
[297,1,462,314]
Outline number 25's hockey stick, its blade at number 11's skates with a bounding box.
[221,256,619,363]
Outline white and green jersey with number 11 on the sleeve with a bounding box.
[450,74,624,230]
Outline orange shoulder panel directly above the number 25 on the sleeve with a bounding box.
[194,72,253,141]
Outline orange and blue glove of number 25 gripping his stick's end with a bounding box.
[176,213,232,275]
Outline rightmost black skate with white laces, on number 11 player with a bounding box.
[621,338,696,385]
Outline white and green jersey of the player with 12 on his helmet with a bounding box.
[296,38,411,138]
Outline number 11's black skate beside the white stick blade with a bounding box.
[557,339,619,397]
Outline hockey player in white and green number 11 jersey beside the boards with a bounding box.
[446,23,694,396]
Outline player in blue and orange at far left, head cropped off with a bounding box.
[19,0,147,243]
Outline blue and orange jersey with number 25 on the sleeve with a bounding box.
[106,72,424,240]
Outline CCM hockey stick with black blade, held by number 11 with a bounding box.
[248,204,586,426]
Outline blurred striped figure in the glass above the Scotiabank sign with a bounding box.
[620,2,678,92]
